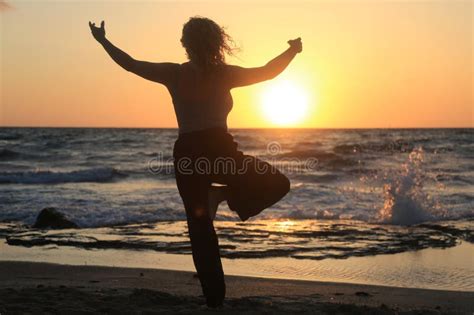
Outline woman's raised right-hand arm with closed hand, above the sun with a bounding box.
[228,38,303,88]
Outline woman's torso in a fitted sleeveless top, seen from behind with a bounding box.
[168,62,232,134]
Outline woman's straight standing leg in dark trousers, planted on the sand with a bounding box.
[176,174,225,307]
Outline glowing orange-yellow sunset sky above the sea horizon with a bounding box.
[0,0,474,128]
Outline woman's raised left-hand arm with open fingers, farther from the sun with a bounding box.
[89,21,179,85]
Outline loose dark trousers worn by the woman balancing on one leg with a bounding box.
[173,128,290,306]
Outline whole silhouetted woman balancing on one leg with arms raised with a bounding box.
[89,17,302,307]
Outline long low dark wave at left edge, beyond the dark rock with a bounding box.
[0,167,127,184]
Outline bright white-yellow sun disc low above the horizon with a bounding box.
[261,81,308,126]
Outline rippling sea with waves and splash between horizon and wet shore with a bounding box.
[0,128,474,290]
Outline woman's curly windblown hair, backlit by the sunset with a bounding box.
[181,16,237,68]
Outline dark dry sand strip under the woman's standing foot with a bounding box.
[0,261,474,314]
